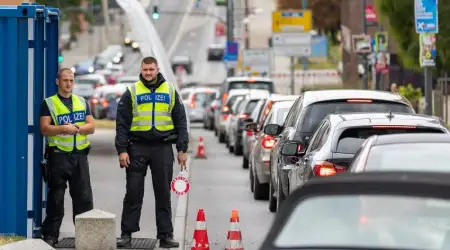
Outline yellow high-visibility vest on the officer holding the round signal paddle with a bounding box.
[128,81,175,131]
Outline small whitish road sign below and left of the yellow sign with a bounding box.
[243,49,272,77]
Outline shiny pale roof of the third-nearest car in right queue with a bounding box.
[329,112,443,128]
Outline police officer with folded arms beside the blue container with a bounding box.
[40,68,95,246]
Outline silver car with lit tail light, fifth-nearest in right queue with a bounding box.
[250,101,295,200]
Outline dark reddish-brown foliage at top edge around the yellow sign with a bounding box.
[277,0,341,37]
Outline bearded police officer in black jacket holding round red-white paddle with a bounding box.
[116,57,189,248]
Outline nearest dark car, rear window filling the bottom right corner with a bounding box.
[259,172,450,250]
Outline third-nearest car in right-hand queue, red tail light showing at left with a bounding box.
[277,113,450,206]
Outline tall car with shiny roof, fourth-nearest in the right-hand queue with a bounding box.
[264,90,415,212]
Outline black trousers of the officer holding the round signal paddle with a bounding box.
[121,143,174,239]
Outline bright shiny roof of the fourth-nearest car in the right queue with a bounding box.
[303,89,411,107]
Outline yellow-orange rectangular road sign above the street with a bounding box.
[272,10,312,33]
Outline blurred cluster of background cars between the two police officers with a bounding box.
[72,42,138,120]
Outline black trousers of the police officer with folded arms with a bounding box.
[41,150,94,238]
